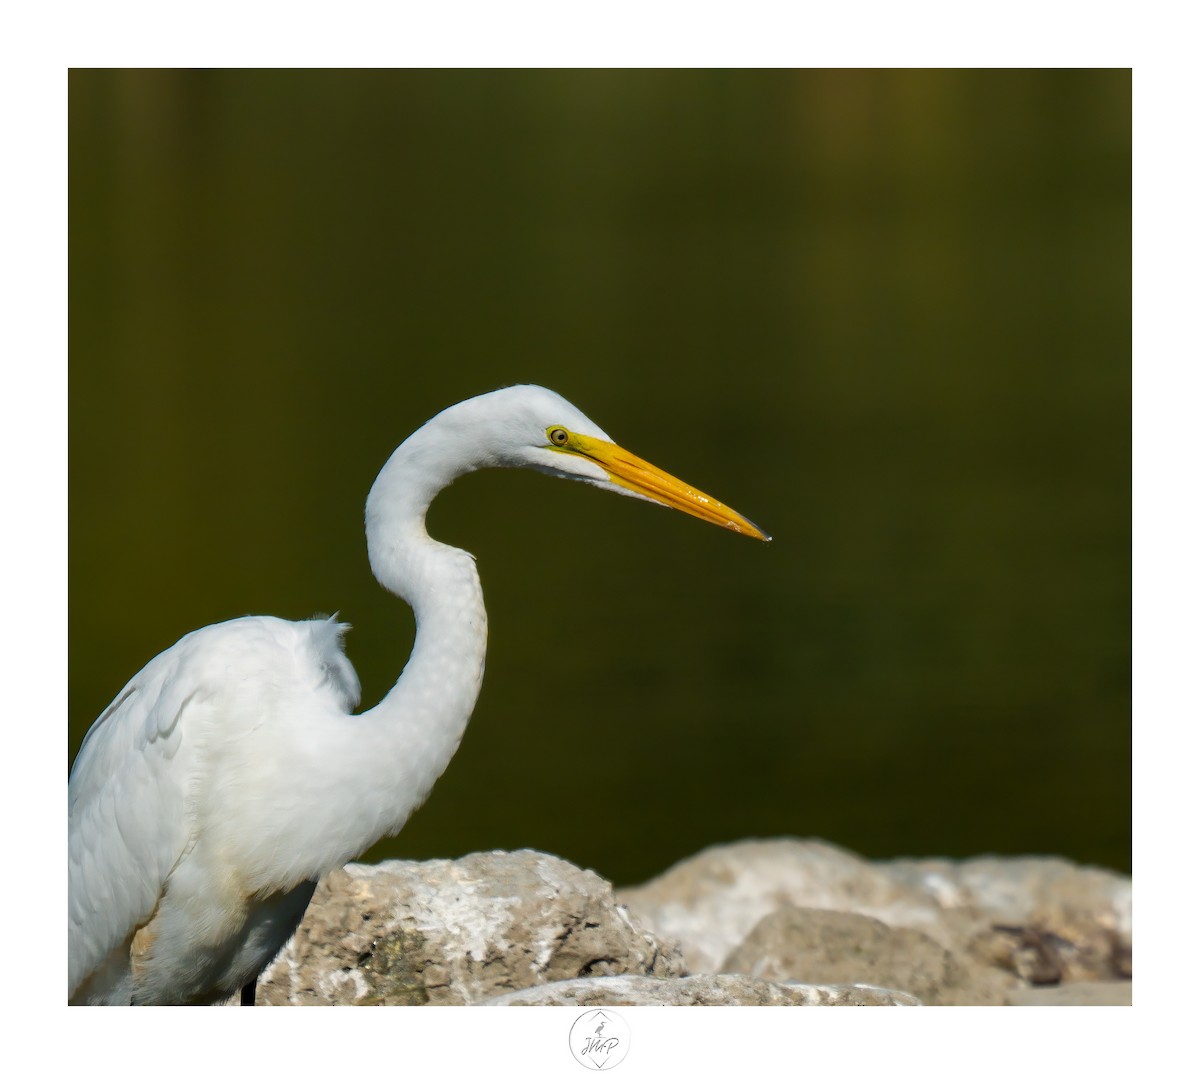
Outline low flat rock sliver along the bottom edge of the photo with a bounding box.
[486,973,919,1007]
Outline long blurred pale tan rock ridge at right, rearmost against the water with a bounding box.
[617,839,1133,994]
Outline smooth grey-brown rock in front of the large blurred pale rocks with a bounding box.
[722,906,1010,1006]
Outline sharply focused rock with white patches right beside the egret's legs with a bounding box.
[258,851,685,1006]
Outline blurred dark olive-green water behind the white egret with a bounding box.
[68,71,1130,882]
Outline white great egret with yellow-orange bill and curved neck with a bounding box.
[67,385,769,1004]
